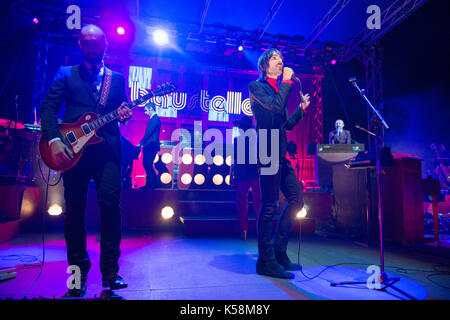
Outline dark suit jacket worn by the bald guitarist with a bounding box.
[41,64,128,161]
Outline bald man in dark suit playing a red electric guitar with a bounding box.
[41,25,131,297]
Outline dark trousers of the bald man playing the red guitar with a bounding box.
[63,142,122,277]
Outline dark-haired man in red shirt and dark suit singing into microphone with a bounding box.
[249,49,310,279]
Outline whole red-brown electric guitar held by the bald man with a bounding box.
[39,83,177,171]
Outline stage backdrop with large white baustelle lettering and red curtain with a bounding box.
[105,58,323,186]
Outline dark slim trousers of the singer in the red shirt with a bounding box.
[258,158,303,261]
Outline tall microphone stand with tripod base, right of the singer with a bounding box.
[331,77,415,300]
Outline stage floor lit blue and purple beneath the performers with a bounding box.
[0,232,450,300]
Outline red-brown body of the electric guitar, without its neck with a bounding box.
[39,112,103,171]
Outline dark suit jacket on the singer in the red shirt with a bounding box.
[248,79,305,158]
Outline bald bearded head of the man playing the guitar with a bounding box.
[78,24,108,65]
